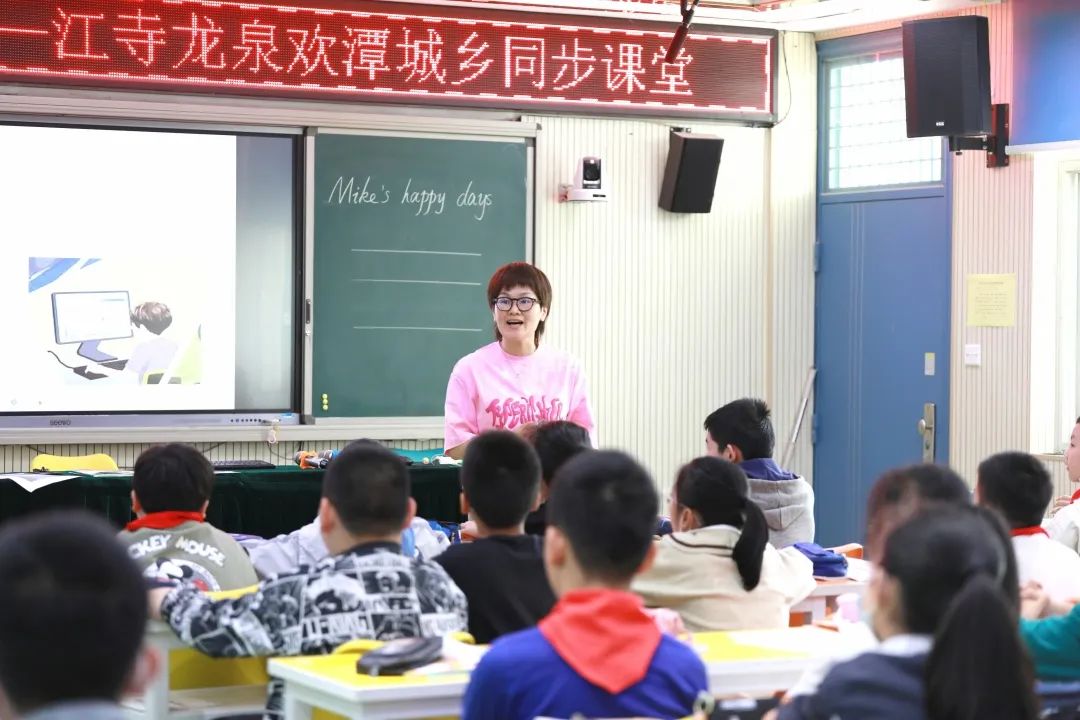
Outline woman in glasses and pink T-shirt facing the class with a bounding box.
[444,262,594,460]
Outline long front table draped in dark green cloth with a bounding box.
[0,465,461,538]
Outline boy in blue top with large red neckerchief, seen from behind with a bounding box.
[462,451,708,720]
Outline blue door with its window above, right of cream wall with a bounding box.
[812,33,951,545]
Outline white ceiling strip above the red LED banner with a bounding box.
[402,0,1002,32]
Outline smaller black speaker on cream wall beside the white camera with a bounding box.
[660,132,724,213]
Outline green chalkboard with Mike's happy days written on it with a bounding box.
[312,134,528,418]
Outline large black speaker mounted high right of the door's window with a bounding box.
[904,15,993,137]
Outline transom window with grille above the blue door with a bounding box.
[825,51,942,191]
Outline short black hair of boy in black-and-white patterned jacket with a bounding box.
[323,440,409,535]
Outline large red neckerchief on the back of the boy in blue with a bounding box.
[539,589,661,694]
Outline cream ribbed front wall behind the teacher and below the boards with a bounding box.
[0,35,816,507]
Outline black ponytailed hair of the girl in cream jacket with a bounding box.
[672,458,769,590]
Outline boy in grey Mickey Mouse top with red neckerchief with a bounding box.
[120,443,258,590]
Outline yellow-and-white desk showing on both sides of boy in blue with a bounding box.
[267,626,843,720]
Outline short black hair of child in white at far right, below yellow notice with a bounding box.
[978,452,1054,528]
